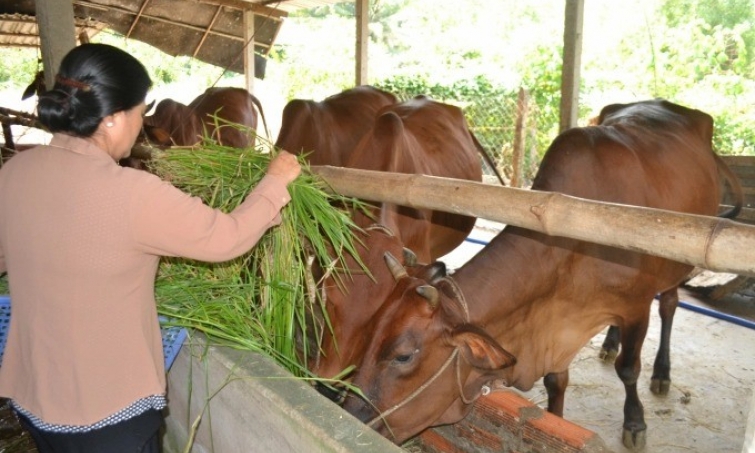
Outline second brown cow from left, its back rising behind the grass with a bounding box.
[275,85,398,167]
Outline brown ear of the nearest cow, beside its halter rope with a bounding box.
[450,324,516,371]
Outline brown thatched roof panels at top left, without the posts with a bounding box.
[0,0,342,77]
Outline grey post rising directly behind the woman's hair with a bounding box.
[35,0,76,88]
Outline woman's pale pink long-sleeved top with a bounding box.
[0,134,290,425]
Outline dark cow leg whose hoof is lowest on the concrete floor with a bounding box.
[614,312,649,449]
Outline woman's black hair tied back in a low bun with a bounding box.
[37,44,152,137]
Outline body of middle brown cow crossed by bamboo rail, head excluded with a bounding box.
[344,96,484,263]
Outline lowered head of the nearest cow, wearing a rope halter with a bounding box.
[344,252,516,444]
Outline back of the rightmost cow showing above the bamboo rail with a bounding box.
[532,100,721,219]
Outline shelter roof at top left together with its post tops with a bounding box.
[0,0,346,88]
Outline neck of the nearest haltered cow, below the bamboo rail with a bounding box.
[446,230,568,390]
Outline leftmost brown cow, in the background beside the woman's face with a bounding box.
[144,87,265,148]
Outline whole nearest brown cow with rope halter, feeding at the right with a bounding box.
[344,100,744,448]
